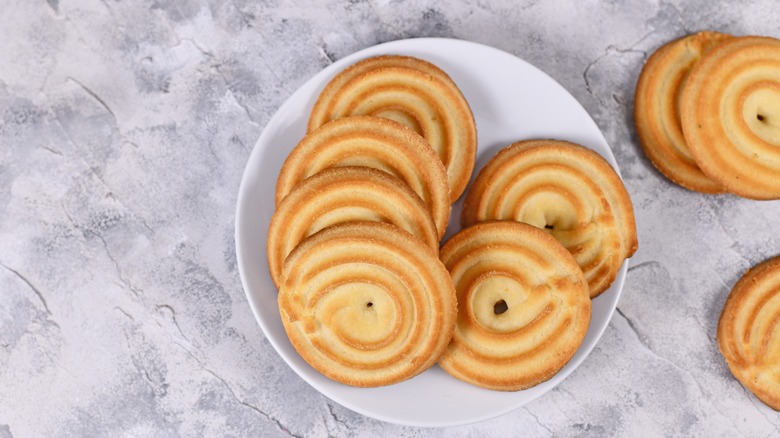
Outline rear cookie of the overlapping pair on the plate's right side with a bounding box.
[461,140,637,298]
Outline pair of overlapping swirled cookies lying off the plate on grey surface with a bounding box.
[634,32,780,199]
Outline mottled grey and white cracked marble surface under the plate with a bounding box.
[0,0,780,438]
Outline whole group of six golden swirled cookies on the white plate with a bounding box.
[267,56,637,391]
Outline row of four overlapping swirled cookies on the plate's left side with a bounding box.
[267,56,476,387]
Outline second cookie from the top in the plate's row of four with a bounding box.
[276,116,450,238]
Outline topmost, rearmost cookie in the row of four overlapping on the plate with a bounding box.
[308,55,477,202]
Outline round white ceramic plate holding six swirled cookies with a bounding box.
[236,38,628,426]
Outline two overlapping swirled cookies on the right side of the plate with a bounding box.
[439,140,637,390]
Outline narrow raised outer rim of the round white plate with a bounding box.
[234,37,630,427]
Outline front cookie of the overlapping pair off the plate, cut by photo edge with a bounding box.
[680,36,780,199]
